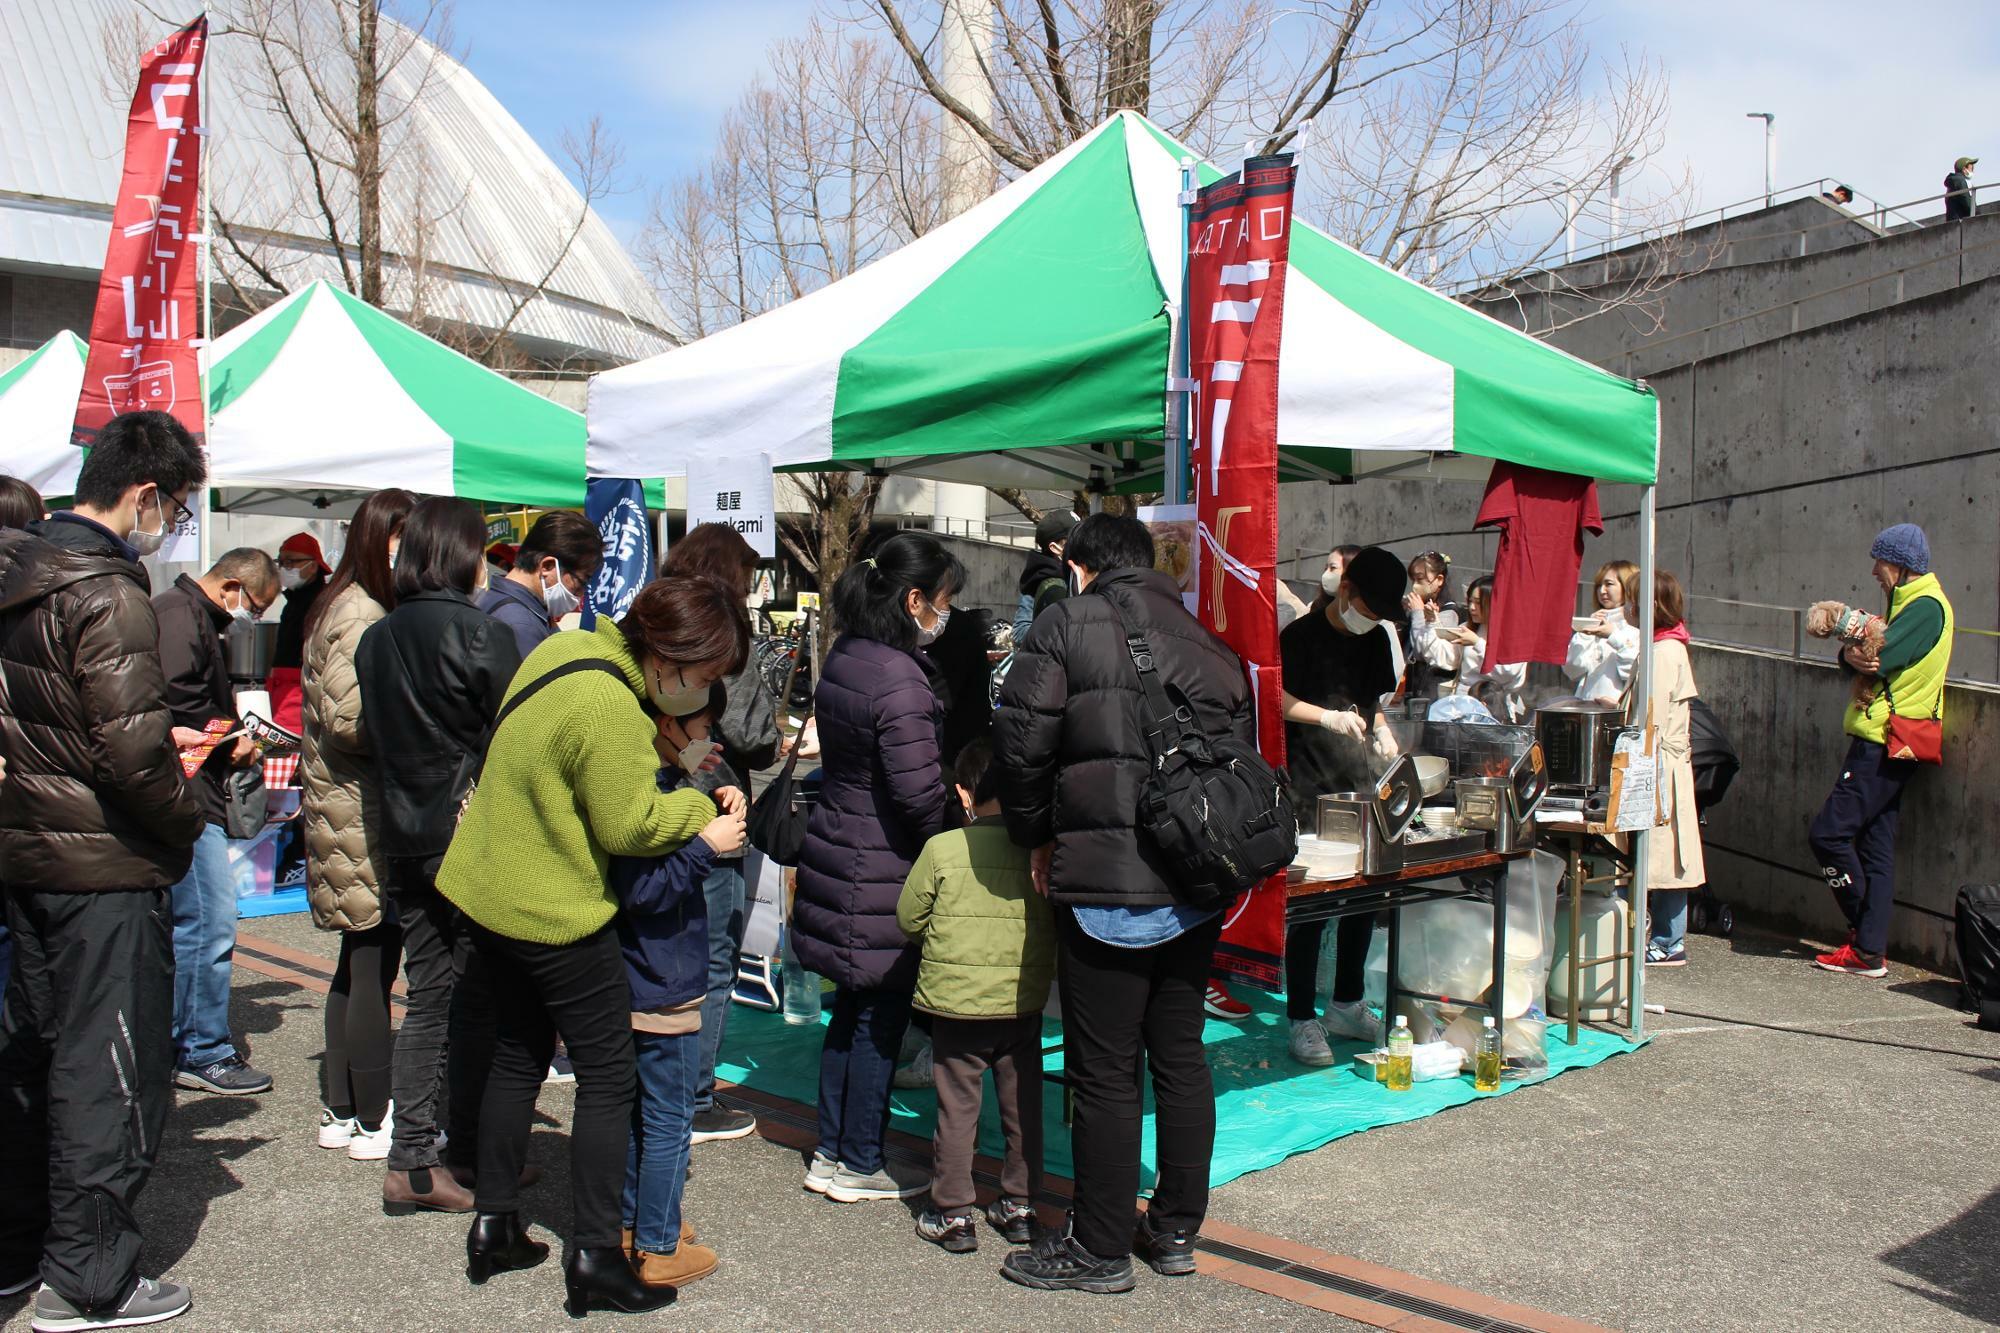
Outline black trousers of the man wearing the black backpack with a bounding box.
[1056,911,1222,1259]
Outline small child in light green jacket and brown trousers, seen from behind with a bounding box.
[896,741,1056,1255]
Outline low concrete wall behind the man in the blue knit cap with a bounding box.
[1694,642,2000,967]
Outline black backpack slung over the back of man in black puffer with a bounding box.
[1104,596,1298,909]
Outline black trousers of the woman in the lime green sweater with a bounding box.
[470,925,638,1251]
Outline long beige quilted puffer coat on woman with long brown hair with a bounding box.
[298,584,388,931]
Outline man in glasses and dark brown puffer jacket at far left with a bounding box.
[0,412,206,1327]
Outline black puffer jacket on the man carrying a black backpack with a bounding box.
[988,568,1256,907]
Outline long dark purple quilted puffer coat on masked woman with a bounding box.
[792,634,956,991]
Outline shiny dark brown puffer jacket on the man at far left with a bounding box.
[0,518,202,880]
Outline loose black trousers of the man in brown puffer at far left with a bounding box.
[0,889,174,1311]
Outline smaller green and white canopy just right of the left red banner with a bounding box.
[208,282,584,506]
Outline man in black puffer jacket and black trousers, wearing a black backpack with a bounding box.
[994,514,1256,1291]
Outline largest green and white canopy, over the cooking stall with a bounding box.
[588,112,1658,486]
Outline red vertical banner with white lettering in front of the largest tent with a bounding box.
[1186,154,1298,991]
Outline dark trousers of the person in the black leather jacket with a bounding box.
[388,861,492,1171]
